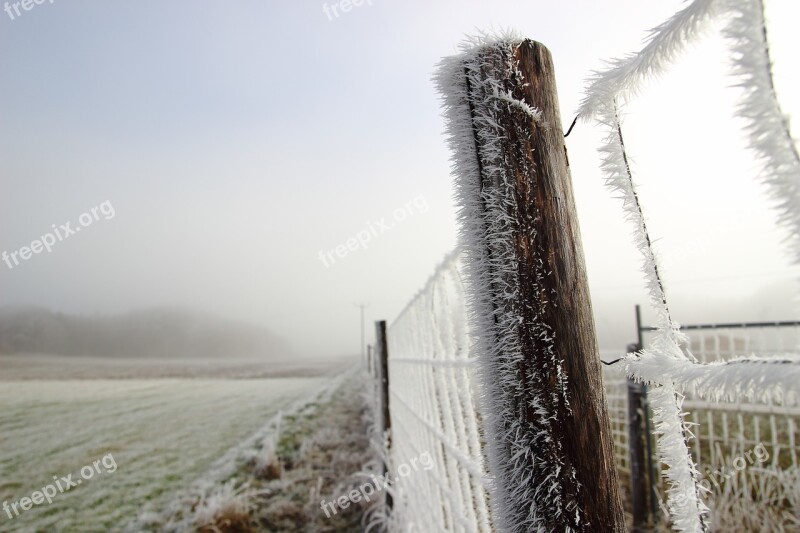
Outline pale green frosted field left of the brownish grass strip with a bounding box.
[0,378,322,533]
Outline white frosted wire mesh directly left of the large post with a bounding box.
[388,253,493,533]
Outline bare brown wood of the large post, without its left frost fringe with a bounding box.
[465,40,625,532]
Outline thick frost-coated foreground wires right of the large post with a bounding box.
[579,0,800,532]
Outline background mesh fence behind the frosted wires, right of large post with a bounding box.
[604,321,800,531]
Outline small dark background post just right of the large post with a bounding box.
[628,344,648,533]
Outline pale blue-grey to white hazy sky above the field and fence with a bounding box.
[0,0,800,355]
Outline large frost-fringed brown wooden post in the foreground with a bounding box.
[439,40,625,532]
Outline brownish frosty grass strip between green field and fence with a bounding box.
[133,373,377,533]
